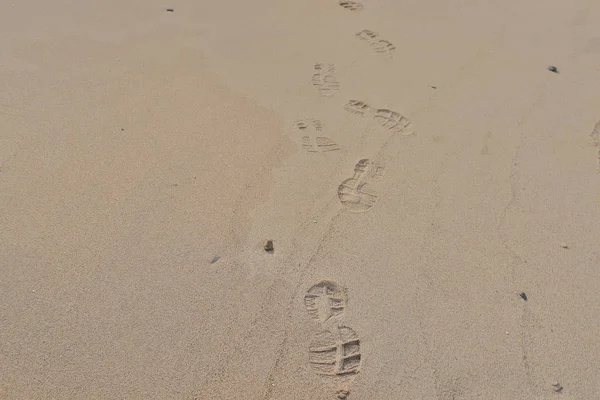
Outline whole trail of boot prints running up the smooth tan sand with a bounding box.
[293,0,412,400]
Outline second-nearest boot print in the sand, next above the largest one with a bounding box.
[338,158,385,213]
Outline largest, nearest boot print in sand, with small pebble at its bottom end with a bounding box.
[304,281,361,399]
